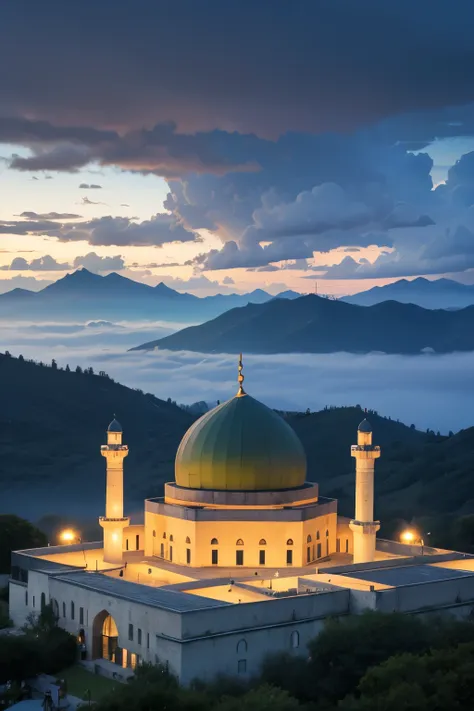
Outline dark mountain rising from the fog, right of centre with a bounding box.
[133,294,474,354]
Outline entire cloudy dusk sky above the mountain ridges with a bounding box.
[0,0,474,296]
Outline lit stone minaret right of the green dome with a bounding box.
[350,420,380,563]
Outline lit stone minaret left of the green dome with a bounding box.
[99,419,130,563]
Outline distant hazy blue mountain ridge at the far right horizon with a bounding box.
[343,277,474,309]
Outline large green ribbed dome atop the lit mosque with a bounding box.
[175,393,306,491]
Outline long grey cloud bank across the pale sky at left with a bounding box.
[0,213,201,247]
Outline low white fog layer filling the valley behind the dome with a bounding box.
[0,323,474,433]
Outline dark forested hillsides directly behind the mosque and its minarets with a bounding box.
[0,354,474,531]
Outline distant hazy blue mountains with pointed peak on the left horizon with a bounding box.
[0,269,299,323]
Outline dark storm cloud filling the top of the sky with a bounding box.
[0,0,474,135]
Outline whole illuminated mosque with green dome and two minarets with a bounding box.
[10,358,474,684]
